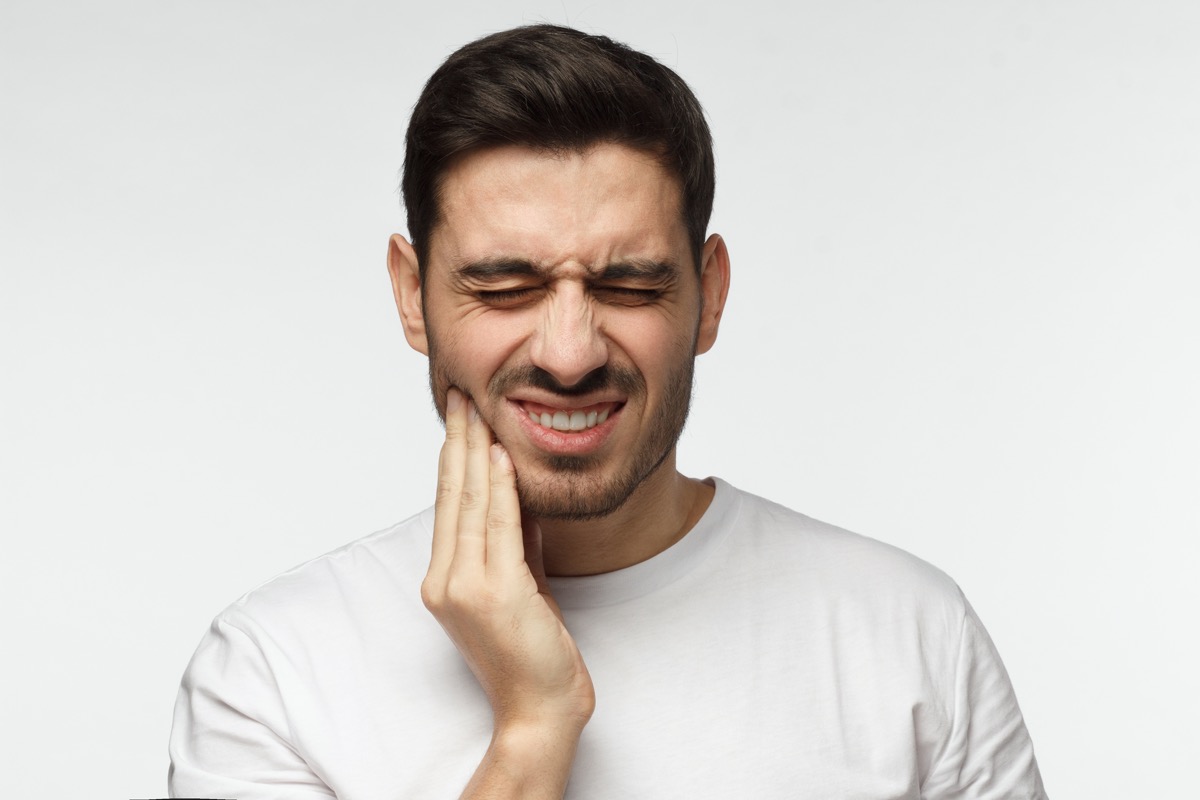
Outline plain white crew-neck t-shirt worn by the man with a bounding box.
[170,480,1045,800]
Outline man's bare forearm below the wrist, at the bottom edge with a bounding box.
[462,723,583,800]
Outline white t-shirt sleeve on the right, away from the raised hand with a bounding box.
[920,600,1046,800]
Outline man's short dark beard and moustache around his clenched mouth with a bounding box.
[430,337,695,521]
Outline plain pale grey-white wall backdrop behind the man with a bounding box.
[0,0,1200,800]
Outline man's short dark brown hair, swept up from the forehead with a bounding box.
[401,25,715,272]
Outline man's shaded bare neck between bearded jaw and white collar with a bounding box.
[538,453,714,576]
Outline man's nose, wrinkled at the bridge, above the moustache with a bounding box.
[529,282,608,386]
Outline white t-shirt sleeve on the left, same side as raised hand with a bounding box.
[168,616,334,800]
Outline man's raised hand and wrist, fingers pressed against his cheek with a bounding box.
[421,389,595,796]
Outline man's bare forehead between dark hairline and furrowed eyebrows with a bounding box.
[430,143,689,277]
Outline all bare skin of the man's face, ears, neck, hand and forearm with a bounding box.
[389,144,728,798]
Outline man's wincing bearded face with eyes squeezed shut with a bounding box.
[402,144,724,519]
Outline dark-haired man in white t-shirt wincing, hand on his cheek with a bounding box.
[170,25,1044,799]
